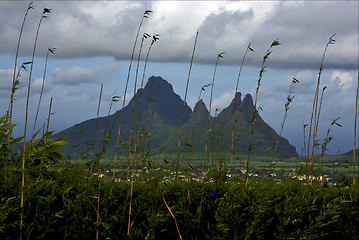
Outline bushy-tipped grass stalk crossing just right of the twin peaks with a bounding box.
[245,39,280,186]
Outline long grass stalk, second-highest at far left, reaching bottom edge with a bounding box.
[20,8,51,236]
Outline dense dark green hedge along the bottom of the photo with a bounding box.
[0,158,359,239]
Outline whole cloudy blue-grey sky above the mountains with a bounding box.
[0,1,359,153]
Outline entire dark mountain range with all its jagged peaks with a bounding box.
[54,76,297,158]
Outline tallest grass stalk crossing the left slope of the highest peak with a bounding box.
[110,10,152,189]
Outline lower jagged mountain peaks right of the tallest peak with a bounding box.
[172,92,298,158]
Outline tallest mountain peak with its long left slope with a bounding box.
[54,76,192,157]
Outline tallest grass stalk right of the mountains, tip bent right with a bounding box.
[307,34,335,178]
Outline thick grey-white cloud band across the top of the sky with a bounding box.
[0,1,358,69]
